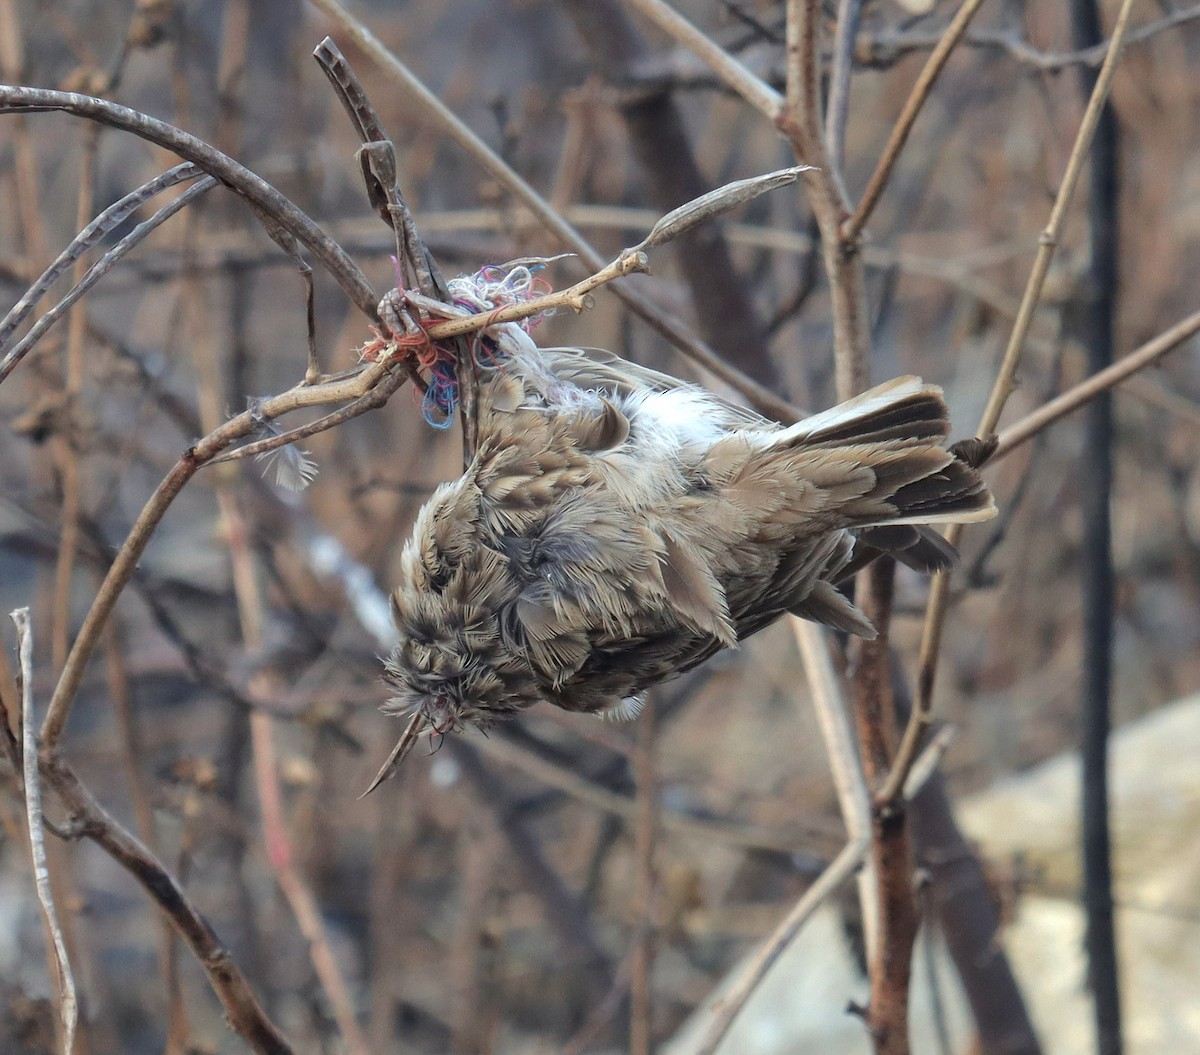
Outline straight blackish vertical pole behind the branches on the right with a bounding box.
[1070,0,1122,1055]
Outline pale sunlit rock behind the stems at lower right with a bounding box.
[665,695,1200,1055]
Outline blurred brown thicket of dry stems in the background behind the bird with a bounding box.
[0,0,1200,1053]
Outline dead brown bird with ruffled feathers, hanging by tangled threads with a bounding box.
[372,324,996,789]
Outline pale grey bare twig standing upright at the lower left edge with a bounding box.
[8,609,79,1055]
